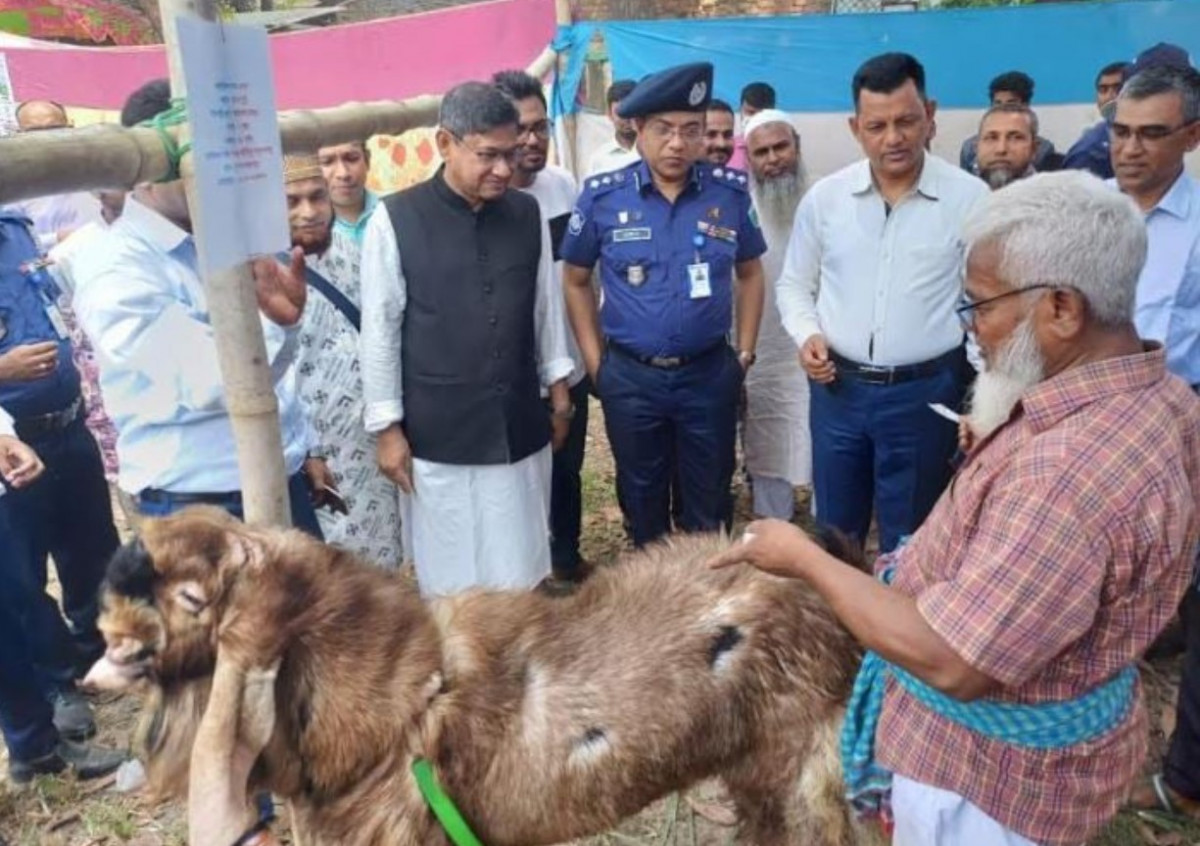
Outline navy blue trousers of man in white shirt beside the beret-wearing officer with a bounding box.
[809,360,966,552]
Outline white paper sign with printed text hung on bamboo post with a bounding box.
[179,18,290,271]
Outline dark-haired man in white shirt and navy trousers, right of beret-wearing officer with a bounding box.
[776,53,988,551]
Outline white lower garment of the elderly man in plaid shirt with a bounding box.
[892,774,1037,846]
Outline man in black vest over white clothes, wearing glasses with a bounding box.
[361,83,575,595]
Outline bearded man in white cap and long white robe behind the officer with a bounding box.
[742,109,812,520]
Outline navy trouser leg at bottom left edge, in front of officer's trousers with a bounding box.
[0,590,59,761]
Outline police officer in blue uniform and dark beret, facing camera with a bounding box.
[562,62,767,546]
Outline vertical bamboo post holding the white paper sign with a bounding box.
[158,0,290,526]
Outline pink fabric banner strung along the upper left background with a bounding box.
[0,0,554,109]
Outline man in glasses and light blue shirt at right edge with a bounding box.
[1111,67,1200,388]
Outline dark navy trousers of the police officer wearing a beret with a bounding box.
[596,347,743,546]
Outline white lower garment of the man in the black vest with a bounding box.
[400,446,551,596]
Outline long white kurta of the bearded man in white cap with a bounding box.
[743,212,812,486]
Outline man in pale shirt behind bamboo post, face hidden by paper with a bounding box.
[74,82,330,538]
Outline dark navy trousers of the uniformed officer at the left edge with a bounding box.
[0,418,119,684]
